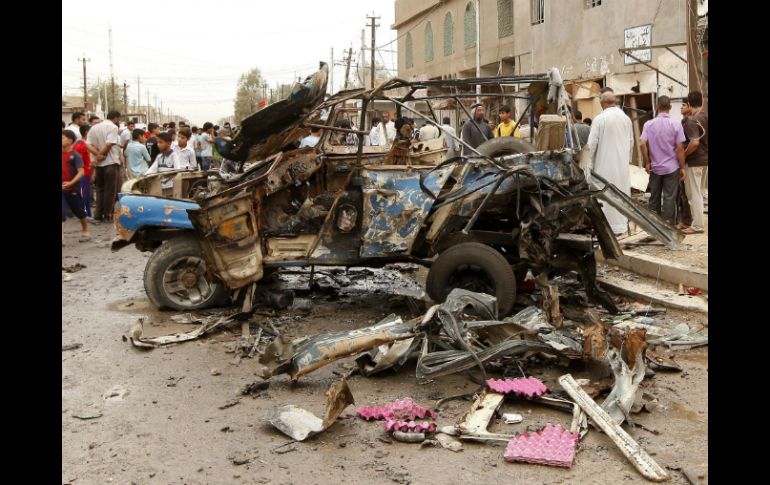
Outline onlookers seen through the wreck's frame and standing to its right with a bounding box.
[354,91,708,235]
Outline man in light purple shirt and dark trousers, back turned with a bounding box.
[640,96,686,224]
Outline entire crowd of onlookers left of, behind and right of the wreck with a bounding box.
[62,87,708,246]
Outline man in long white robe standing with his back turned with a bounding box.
[587,91,634,235]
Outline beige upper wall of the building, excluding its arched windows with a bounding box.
[394,0,687,97]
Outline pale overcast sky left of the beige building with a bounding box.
[62,0,397,124]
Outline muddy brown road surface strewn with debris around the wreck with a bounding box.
[62,220,708,485]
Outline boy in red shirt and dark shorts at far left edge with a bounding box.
[61,130,91,246]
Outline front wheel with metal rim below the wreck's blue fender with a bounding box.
[144,237,229,311]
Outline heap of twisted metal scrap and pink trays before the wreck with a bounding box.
[255,289,707,481]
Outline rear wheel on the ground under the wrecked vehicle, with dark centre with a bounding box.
[425,242,516,317]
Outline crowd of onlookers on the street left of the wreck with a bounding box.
[62,111,233,246]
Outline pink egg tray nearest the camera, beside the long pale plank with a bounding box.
[503,423,579,468]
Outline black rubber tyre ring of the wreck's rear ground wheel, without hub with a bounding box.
[425,242,516,318]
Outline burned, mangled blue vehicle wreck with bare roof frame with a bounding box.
[113,64,681,315]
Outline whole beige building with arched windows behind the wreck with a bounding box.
[392,0,708,163]
